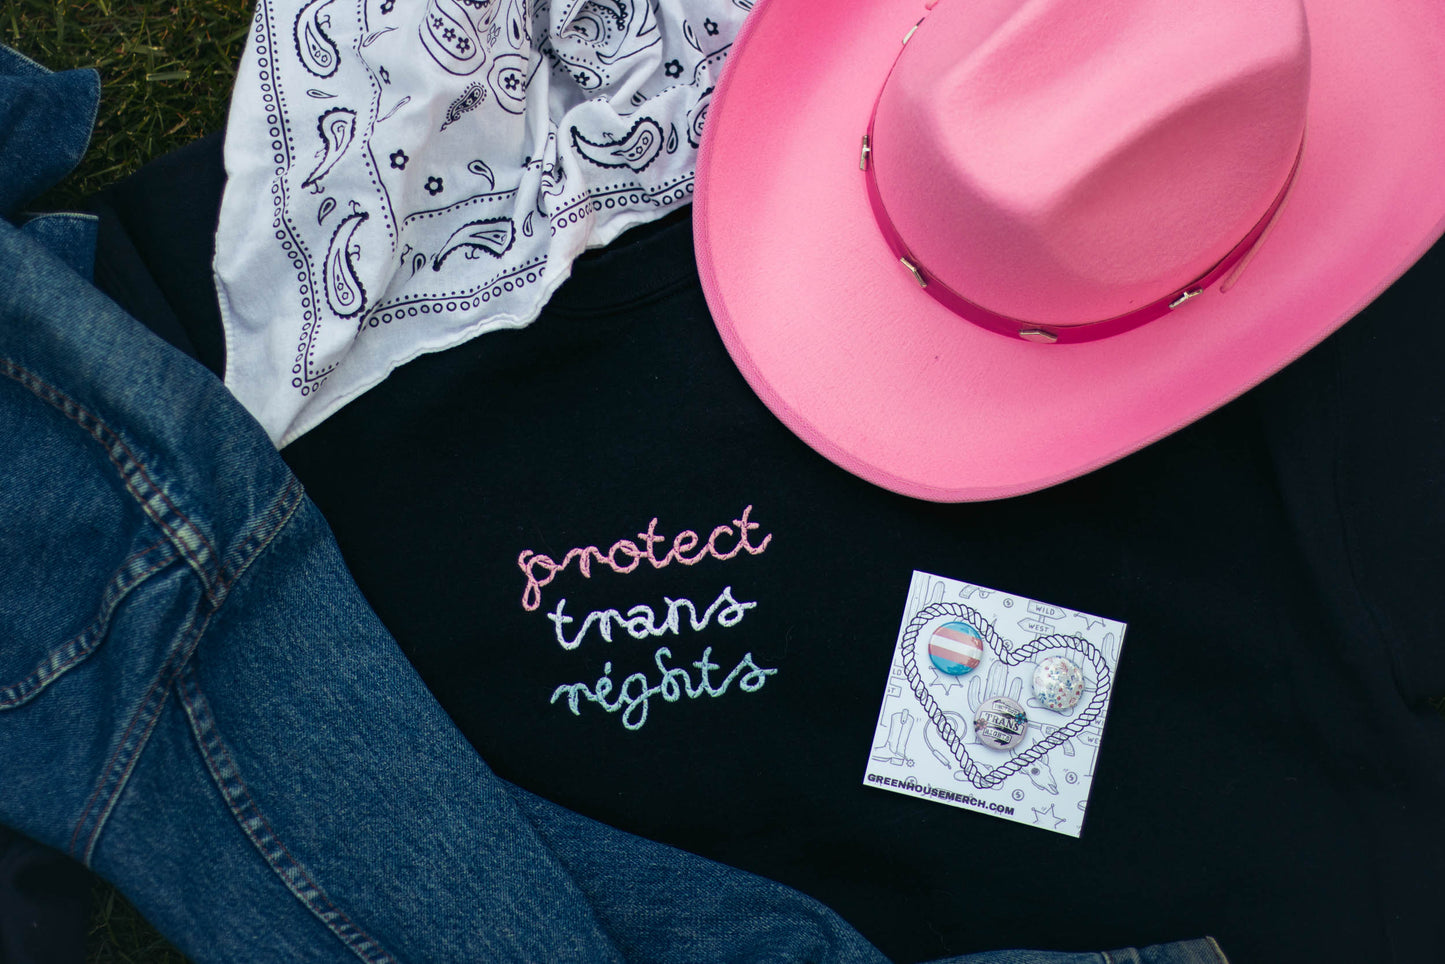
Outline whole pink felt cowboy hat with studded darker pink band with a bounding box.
[694,0,1445,502]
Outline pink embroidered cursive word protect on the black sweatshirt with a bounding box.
[517,506,773,613]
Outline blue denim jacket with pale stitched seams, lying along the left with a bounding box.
[0,41,1222,964]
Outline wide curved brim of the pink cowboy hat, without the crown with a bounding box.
[694,0,1445,502]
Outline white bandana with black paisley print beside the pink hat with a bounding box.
[215,0,753,445]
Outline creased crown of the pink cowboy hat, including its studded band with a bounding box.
[860,0,1309,344]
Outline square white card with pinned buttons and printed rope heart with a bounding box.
[863,571,1126,837]
